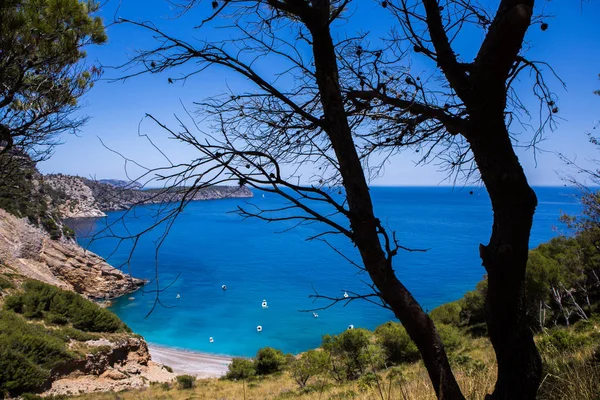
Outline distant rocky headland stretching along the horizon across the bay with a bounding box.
[44,174,253,218]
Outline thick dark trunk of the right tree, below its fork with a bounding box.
[466,113,542,400]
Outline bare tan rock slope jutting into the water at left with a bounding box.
[0,209,145,299]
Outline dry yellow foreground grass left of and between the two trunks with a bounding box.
[72,340,496,400]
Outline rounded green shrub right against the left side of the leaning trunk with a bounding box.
[375,321,421,365]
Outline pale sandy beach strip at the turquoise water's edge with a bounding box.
[148,344,231,378]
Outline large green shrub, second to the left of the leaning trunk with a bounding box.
[322,329,385,381]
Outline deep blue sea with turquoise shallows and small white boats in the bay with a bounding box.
[70,187,580,356]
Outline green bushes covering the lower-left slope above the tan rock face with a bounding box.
[0,274,129,396]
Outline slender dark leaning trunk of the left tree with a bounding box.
[307,10,464,400]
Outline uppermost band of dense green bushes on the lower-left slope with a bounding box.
[4,280,128,332]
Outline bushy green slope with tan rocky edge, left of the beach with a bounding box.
[0,276,174,398]
